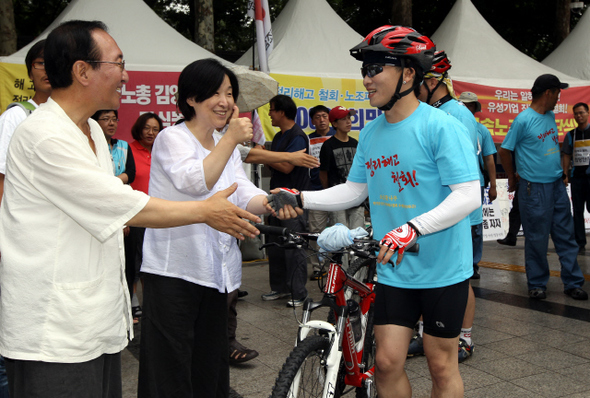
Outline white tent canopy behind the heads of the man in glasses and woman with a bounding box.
[0,0,224,72]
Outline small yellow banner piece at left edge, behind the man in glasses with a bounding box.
[0,62,35,113]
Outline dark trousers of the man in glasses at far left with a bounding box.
[5,353,123,398]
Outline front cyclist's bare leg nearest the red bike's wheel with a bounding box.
[375,325,414,398]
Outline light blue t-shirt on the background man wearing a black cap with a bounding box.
[502,108,563,183]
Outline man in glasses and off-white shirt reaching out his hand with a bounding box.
[0,21,259,398]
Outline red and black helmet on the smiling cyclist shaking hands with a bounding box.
[350,25,436,72]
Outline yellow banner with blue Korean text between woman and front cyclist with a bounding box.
[258,72,382,141]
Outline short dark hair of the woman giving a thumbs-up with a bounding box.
[177,58,240,120]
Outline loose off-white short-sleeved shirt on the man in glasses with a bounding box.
[0,98,149,363]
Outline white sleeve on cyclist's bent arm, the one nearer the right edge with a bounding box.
[410,180,481,235]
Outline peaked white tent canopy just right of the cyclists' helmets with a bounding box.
[431,0,589,89]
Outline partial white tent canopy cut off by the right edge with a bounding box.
[542,7,590,80]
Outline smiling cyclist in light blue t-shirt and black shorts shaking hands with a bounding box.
[270,26,480,398]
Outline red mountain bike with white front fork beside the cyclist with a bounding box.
[256,225,418,398]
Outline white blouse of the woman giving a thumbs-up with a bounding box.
[141,123,266,293]
